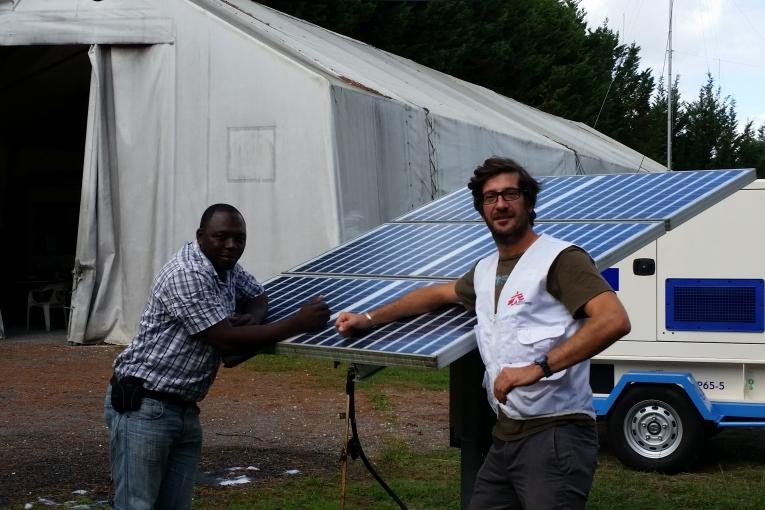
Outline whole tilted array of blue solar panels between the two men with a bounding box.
[266,170,755,368]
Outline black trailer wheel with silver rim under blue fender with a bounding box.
[608,385,706,473]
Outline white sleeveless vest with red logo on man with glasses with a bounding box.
[474,234,595,419]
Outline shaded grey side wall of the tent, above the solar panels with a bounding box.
[331,86,580,240]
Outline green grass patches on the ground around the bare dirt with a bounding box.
[210,356,765,510]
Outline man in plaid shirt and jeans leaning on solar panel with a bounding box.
[104,204,330,510]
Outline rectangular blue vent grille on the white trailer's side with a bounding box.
[666,278,765,332]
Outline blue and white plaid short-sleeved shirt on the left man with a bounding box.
[114,242,264,401]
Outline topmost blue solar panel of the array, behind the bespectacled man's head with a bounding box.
[398,170,753,222]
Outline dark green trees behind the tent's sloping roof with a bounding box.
[261,0,765,177]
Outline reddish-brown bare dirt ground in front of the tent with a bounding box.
[0,332,449,508]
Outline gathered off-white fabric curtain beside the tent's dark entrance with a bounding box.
[69,45,175,343]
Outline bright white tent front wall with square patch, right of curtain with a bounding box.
[175,0,339,280]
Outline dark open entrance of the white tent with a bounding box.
[0,45,91,337]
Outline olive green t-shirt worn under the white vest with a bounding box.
[455,246,612,441]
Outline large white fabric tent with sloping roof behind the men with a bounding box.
[0,0,664,343]
